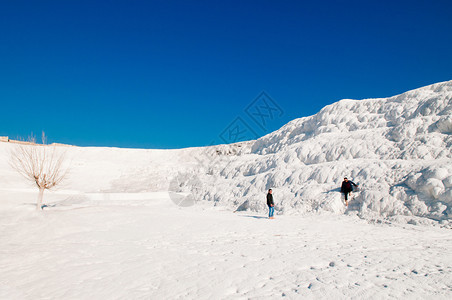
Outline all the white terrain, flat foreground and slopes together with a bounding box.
[0,81,452,299]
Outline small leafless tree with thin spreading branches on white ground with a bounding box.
[10,132,69,210]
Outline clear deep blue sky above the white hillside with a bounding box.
[0,0,452,148]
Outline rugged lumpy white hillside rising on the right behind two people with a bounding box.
[192,81,452,223]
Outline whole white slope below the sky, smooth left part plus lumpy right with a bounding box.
[0,81,452,225]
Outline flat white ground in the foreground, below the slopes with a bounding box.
[0,196,452,299]
